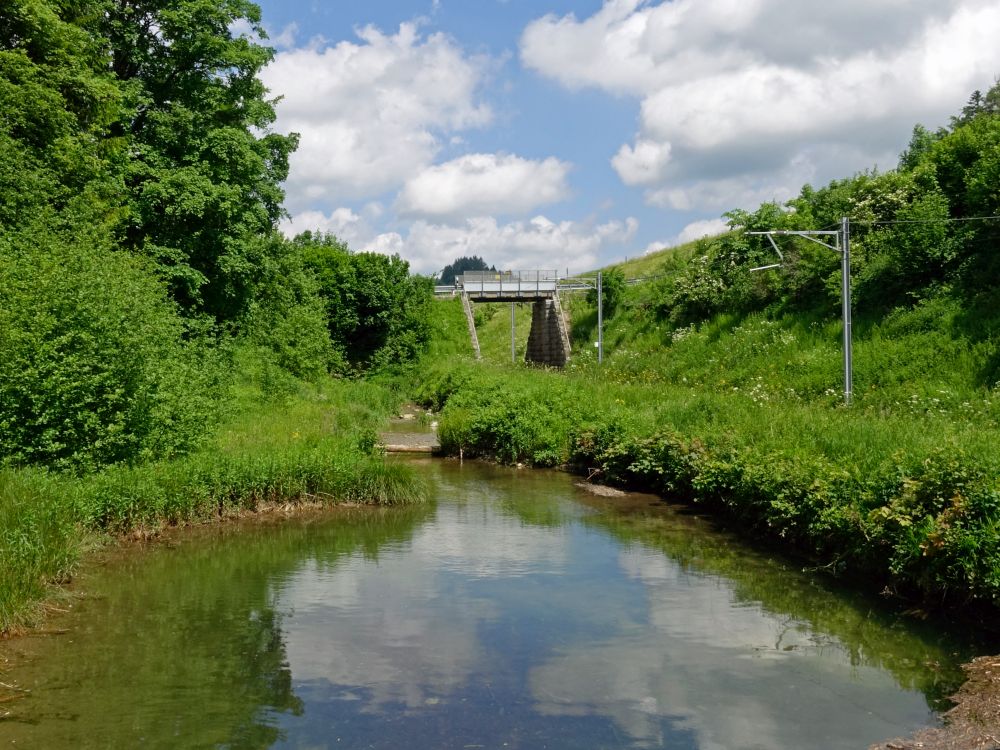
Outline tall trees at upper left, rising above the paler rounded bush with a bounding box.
[0,0,296,321]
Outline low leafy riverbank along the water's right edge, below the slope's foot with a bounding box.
[417,363,1000,616]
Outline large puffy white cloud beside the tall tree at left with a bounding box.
[261,23,492,213]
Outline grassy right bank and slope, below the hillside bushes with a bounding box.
[416,256,1000,607]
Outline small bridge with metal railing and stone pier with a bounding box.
[452,271,570,367]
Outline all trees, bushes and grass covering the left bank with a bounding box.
[0,0,442,633]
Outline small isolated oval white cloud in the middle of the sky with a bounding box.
[396,154,570,219]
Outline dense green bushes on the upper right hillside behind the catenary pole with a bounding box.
[654,84,1000,327]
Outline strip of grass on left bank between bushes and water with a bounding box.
[0,381,424,632]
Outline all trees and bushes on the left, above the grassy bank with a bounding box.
[0,0,430,469]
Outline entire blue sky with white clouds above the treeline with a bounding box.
[250,0,1000,273]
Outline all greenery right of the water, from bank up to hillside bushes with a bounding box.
[417,84,1000,613]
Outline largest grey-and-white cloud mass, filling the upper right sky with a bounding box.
[521,0,1000,209]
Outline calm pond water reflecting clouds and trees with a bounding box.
[0,459,988,750]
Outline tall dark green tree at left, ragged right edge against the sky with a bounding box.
[101,0,297,321]
